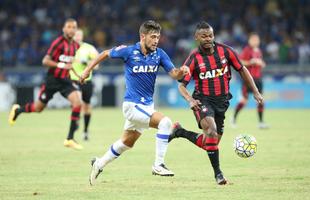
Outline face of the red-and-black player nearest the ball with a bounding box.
[195,28,214,49]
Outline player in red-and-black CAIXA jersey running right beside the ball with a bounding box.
[169,21,263,185]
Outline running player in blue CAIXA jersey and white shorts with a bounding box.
[80,20,189,185]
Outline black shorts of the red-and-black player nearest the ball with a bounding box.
[193,93,232,135]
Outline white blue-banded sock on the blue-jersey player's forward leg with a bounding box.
[155,117,172,166]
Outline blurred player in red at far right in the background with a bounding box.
[232,33,268,129]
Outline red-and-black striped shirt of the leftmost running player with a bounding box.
[47,36,79,79]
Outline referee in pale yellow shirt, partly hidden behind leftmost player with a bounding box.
[70,29,98,140]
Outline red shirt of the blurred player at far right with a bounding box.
[240,46,263,79]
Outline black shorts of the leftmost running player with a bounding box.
[39,75,78,104]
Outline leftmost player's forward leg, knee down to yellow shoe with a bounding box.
[64,90,83,150]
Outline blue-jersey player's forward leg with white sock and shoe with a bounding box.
[149,112,174,176]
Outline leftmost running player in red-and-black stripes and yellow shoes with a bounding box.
[9,18,83,149]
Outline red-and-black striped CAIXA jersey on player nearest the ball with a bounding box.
[182,42,243,96]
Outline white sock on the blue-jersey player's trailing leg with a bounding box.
[98,139,130,169]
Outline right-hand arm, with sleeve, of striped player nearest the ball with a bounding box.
[227,48,264,103]
